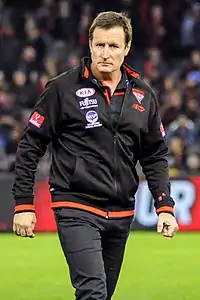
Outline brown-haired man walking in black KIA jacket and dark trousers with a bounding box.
[13,12,178,300]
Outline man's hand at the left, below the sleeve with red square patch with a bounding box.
[13,212,36,238]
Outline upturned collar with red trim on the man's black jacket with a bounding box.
[80,57,140,81]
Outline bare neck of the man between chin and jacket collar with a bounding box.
[91,63,122,84]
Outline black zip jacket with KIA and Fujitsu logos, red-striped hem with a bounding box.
[13,59,174,217]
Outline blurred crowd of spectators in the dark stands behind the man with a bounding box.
[0,0,200,176]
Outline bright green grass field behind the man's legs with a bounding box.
[0,232,200,300]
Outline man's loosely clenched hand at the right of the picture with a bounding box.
[157,213,179,238]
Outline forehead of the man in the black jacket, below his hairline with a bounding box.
[93,26,125,43]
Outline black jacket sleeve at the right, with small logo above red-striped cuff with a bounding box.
[140,92,175,214]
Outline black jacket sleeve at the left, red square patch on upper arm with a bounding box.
[12,80,59,213]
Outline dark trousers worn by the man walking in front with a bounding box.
[55,208,132,300]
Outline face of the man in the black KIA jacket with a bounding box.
[90,27,130,74]
